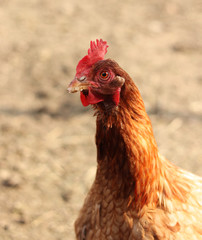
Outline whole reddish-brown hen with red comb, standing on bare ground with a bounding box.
[68,40,202,240]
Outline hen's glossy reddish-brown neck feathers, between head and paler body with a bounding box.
[96,74,190,210]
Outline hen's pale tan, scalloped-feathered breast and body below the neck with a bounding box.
[75,158,202,240]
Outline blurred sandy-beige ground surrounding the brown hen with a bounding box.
[0,0,202,240]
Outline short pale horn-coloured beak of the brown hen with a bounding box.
[67,76,90,93]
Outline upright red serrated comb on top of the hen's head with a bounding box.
[76,39,108,78]
